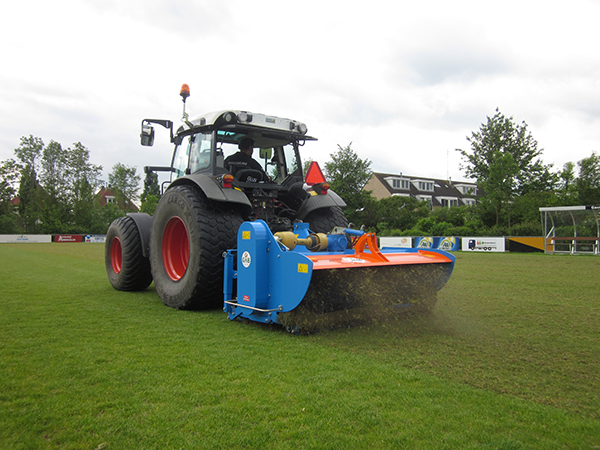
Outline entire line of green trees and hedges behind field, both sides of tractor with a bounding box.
[0,110,600,236]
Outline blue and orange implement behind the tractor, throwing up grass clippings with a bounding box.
[223,220,455,332]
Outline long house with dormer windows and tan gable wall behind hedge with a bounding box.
[363,172,478,209]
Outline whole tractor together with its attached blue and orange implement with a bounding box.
[105,84,454,333]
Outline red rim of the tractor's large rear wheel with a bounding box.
[162,217,190,281]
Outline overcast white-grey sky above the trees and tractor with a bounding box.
[0,0,600,185]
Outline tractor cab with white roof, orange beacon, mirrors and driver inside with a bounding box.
[141,85,346,231]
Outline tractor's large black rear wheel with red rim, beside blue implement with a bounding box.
[150,185,243,310]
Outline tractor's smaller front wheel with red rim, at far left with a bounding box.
[104,216,152,291]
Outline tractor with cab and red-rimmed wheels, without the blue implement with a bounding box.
[105,85,348,309]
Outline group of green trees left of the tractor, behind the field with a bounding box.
[0,135,145,234]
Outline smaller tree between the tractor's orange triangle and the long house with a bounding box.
[325,142,373,223]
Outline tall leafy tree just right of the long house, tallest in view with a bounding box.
[456,109,557,225]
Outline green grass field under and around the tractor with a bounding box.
[0,244,600,450]
